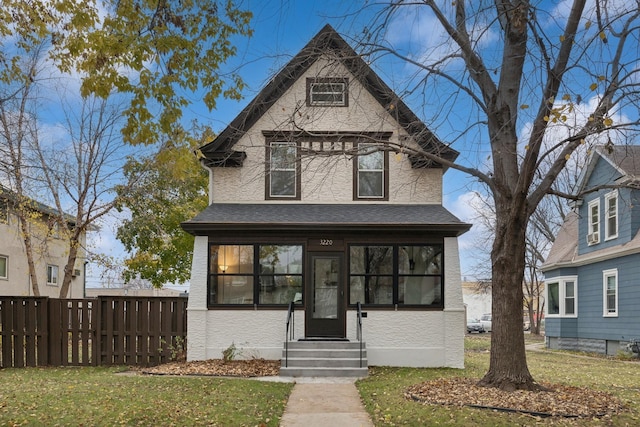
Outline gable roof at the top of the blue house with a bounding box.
[573,145,640,194]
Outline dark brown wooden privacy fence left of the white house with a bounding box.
[0,296,187,368]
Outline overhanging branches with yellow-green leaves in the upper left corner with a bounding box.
[0,0,251,144]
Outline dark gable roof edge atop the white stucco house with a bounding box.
[200,24,459,167]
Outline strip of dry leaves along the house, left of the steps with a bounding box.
[142,359,280,378]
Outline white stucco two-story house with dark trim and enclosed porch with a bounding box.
[183,25,470,367]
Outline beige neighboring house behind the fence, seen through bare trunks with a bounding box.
[0,189,86,298]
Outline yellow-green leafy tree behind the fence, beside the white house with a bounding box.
[117,133,208,287]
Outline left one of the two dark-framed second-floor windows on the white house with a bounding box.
[266,141,300,200]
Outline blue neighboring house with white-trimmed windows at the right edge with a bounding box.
[542,146,640,355]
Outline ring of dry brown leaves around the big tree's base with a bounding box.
[405,378,624,417]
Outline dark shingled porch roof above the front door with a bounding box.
[182,203,471,236]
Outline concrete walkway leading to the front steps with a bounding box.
[280,378,373,427]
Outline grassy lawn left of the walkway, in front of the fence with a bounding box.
[0,367,293,426]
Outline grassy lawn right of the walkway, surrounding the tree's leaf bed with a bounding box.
[357,334,640,426]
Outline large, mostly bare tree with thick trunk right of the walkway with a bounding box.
[352,0,640,390]
